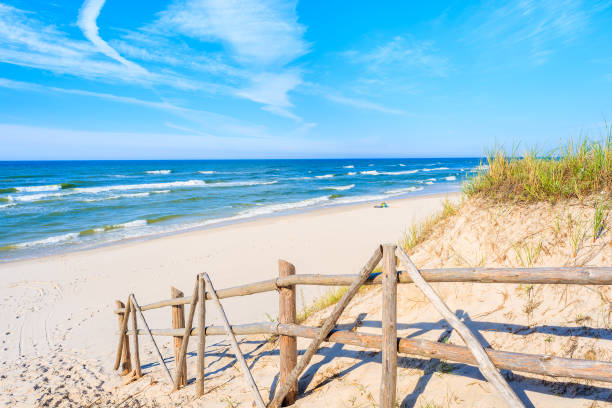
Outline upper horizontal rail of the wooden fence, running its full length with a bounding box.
[115,267,612,313]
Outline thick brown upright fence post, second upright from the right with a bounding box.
[278,259,297,406]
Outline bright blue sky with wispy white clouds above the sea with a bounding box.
[0,0,612,160]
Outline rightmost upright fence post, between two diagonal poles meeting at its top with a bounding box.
[380,244,397,408]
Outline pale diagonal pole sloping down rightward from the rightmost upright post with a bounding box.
[397,248,524,408]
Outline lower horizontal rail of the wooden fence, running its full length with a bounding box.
[128,322,612,383]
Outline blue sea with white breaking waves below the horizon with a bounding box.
[0,158,480,261]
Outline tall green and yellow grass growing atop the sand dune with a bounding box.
[463,127,612,202]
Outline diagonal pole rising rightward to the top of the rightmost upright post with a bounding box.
[268,247,382,408]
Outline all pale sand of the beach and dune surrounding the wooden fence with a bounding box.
[0,195,612,408]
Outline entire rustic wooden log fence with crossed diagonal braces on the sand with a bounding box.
[115,244,612,408]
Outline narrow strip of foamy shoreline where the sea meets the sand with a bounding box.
[0,189,462,266]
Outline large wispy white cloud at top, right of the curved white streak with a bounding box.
[145,0,309,121]
